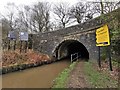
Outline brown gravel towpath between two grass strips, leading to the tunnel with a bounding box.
[66,61,89,88]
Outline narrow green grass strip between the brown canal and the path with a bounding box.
[52,62,77,89]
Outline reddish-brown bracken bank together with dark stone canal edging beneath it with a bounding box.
[0,51,52,74]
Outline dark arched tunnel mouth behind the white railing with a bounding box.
[55,40,89,60]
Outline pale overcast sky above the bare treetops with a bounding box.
[0,0,118,26]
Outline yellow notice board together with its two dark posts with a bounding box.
[96,24,112,71]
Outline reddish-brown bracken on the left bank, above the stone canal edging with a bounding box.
[2,50,50,67]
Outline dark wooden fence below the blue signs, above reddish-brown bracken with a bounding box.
[2,34,33,52]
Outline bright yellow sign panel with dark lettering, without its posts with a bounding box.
[96,25,110,46]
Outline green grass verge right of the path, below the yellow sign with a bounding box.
[84,62,118,88]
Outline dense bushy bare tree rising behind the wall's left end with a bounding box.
[31,2,50,32]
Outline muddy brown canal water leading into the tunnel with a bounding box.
[2,60,70,88]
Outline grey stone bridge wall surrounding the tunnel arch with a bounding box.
[33,11,109,60]
